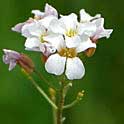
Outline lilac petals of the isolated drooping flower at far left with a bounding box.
[3,49,21,71]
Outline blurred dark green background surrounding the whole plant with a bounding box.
[0,0,124,124]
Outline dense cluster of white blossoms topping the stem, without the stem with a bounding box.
[12,4,113,80]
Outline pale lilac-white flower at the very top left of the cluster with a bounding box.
[32,4,58,19]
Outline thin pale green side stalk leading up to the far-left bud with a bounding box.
[28,76,57,110]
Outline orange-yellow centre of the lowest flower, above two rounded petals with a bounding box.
[58,48,77,58]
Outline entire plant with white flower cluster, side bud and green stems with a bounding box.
[3,4,113,124]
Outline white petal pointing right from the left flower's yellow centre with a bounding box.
[43,34,65,50]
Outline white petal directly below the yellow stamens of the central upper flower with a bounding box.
[65,36,81,48]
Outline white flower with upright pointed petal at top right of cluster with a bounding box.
[80,9,101,23]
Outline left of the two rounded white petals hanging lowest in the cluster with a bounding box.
[45,54,66,75]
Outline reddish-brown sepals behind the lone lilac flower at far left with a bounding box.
[17,54,34,74]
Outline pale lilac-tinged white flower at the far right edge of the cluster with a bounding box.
[91,18,113,42]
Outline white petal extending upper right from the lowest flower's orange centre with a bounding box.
[76,38,96,53]
